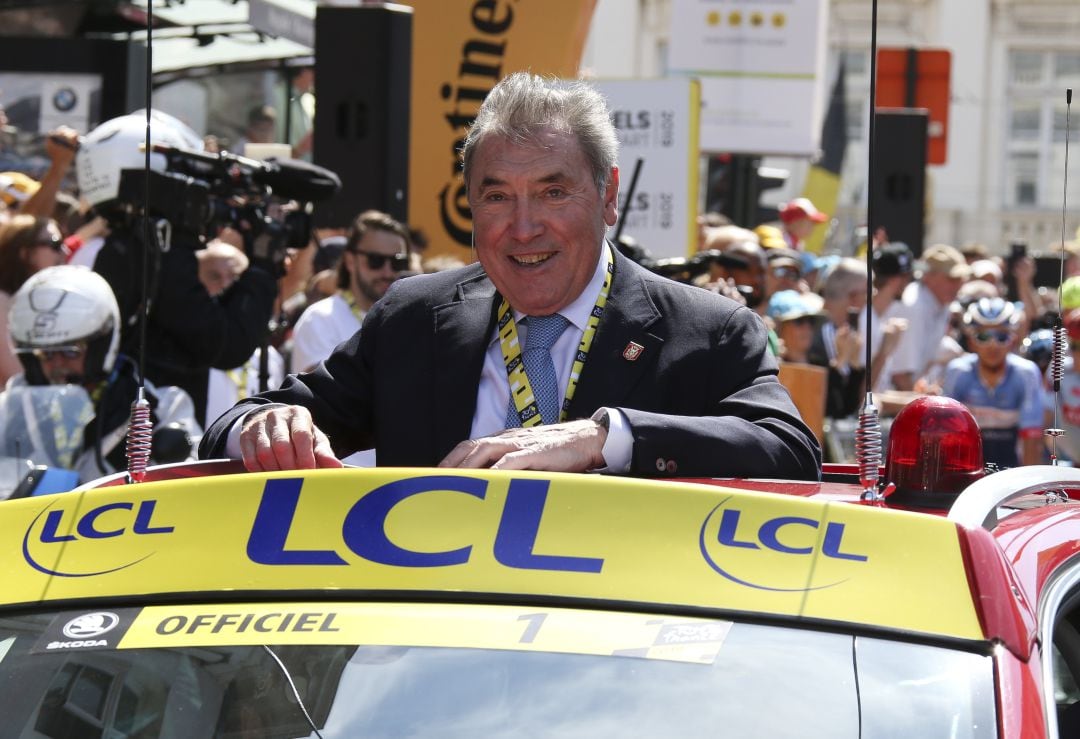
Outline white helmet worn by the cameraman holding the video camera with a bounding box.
[76,109,203,206]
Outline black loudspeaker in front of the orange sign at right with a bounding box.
[870,109,927,257]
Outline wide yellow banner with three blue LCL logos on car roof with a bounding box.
[0,468,982,639]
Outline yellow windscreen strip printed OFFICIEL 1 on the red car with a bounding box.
[117,603,731,664]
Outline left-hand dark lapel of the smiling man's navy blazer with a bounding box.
[429,276,496,455]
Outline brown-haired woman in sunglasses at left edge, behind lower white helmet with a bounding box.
[0,214,66,386]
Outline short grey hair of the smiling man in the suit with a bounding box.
[461,72,619,192]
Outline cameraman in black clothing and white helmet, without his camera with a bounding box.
[77,111,283,424]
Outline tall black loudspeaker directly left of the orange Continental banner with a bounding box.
[312,5,413,227]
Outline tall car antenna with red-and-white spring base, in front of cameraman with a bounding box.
[126,0,154,483]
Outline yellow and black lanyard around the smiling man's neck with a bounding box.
[499,245,615,428]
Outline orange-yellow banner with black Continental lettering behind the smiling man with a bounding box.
[408,0,596,261]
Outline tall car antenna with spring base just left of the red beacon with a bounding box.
[855,0,896,506]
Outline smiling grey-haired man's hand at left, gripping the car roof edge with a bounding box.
[240,405,343,472]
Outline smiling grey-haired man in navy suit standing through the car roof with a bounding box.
[201,73,820,479]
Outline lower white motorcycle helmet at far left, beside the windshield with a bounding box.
[8,265,120,385]
